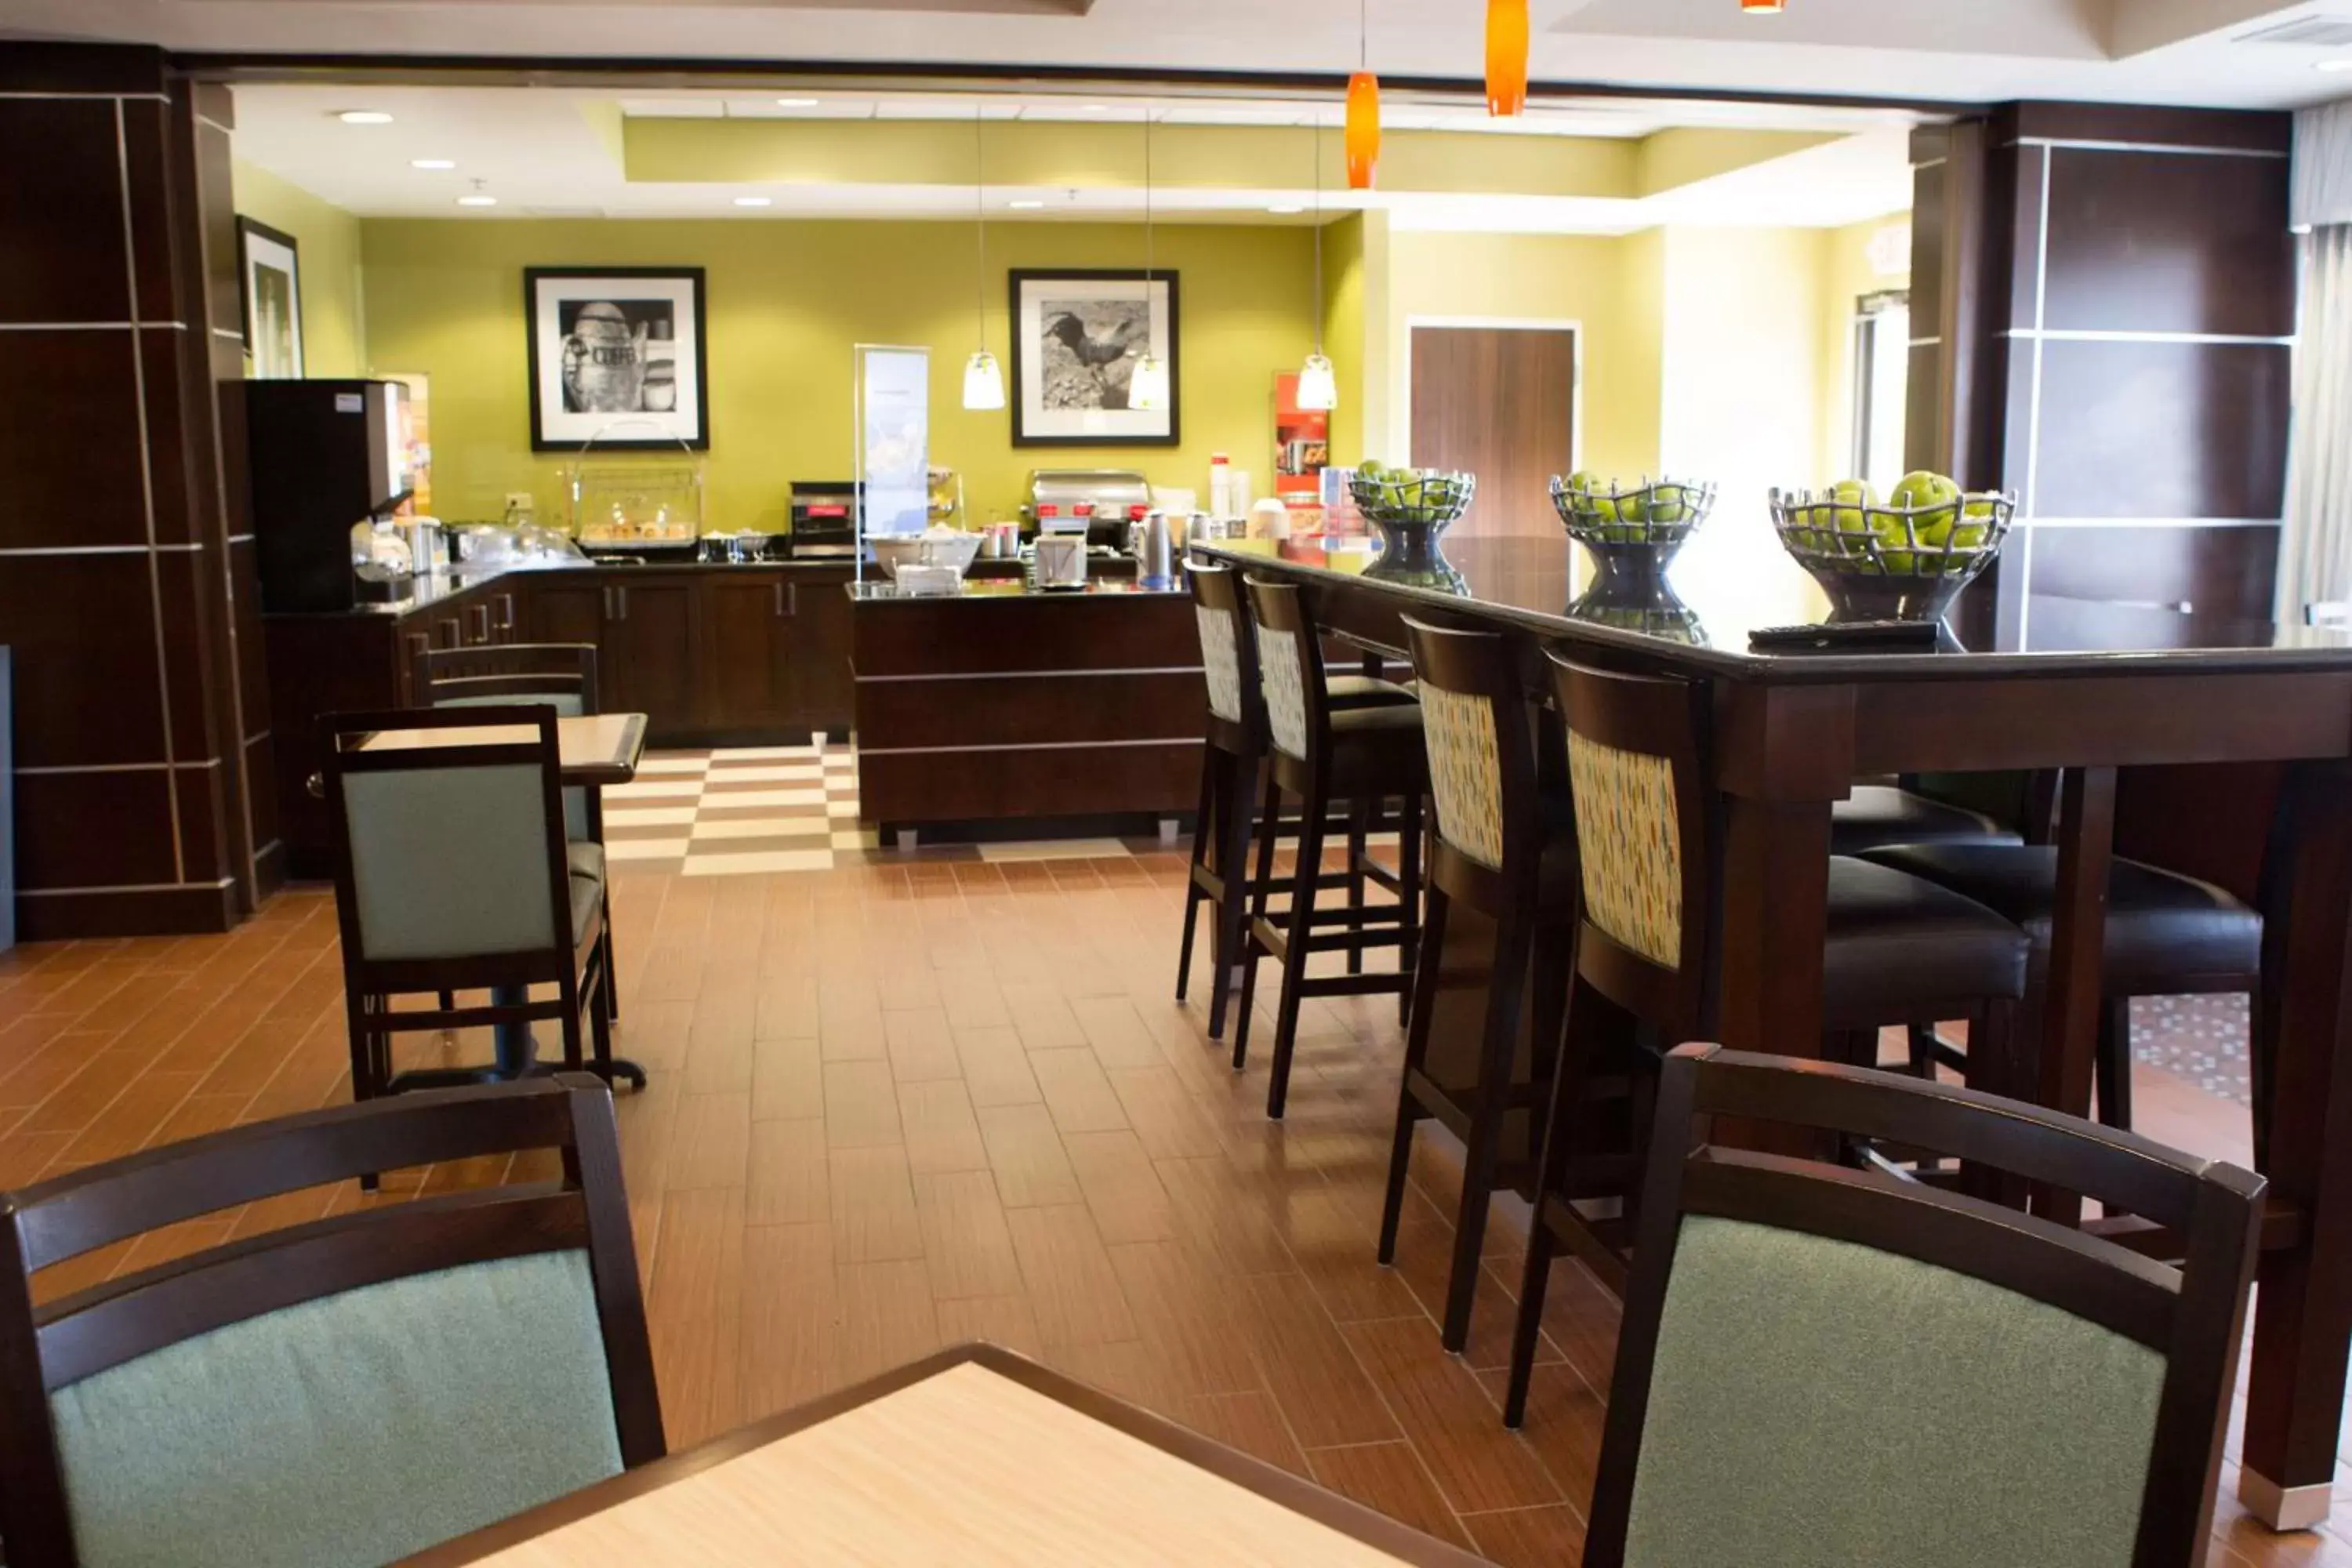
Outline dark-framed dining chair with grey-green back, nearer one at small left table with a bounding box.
[318,703,626,1100]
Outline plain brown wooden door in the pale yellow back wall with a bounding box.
[1414,327,1581,539]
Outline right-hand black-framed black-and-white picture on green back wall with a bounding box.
[1011,270,1183,447]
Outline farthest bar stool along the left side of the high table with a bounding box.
[1176,562,1414,1039]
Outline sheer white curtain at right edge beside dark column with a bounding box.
[2277,223,2352,623]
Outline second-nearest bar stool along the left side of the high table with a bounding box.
[1381,616,1576,1352]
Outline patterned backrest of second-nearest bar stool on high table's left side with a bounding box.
[1404,616,1541,895]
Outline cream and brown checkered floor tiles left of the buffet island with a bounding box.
[604,746,873,877]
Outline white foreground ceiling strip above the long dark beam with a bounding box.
[18,0,2352,108]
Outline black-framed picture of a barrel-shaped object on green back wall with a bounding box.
[522,266,710,452]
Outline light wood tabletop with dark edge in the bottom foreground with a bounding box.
[395,1345,1479,1568]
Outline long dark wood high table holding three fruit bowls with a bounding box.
[1197,536,2352,1528]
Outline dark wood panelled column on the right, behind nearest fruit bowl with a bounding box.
[1910,103,2296,647]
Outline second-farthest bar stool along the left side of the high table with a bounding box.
[1232,579,1430,1121]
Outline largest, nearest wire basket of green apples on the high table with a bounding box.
[1771,489,2018,621]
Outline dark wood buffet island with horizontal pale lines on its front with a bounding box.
[847,581,1204,844]
